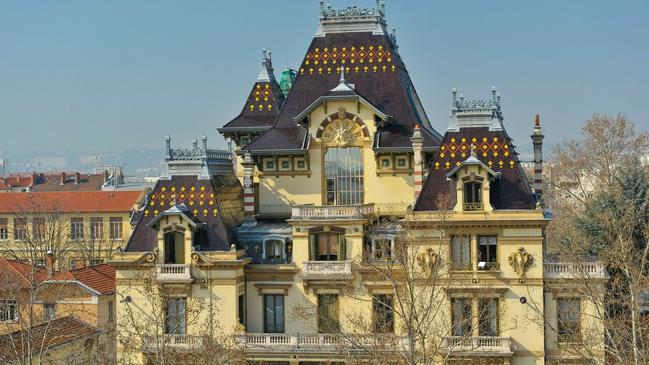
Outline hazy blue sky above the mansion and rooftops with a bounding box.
[0,0,649,158]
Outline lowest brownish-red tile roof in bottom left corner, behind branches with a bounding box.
[0,316,99,364]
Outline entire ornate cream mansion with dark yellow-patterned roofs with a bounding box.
[112,2,606,365]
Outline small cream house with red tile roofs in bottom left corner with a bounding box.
[0,259,115,363]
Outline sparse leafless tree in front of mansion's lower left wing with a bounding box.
[117,271,245,365]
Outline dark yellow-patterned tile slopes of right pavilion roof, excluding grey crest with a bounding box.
[413,127,536,211]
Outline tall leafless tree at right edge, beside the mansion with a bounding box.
[546,115,649,364]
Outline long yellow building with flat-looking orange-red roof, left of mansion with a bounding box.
[0,190,147,268]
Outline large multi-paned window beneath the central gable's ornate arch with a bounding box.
[324,147,363,205]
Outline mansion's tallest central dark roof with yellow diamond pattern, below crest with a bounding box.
[245,24,441,154]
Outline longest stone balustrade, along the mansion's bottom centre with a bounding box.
[236,333,409,353]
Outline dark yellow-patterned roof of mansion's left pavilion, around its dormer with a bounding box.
[126,176,243,252]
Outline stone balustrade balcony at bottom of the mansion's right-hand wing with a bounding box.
[441,336,514,356]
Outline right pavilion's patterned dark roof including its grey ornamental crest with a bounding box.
[414,90,536,211]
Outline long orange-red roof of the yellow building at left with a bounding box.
[0,191,144,213]
